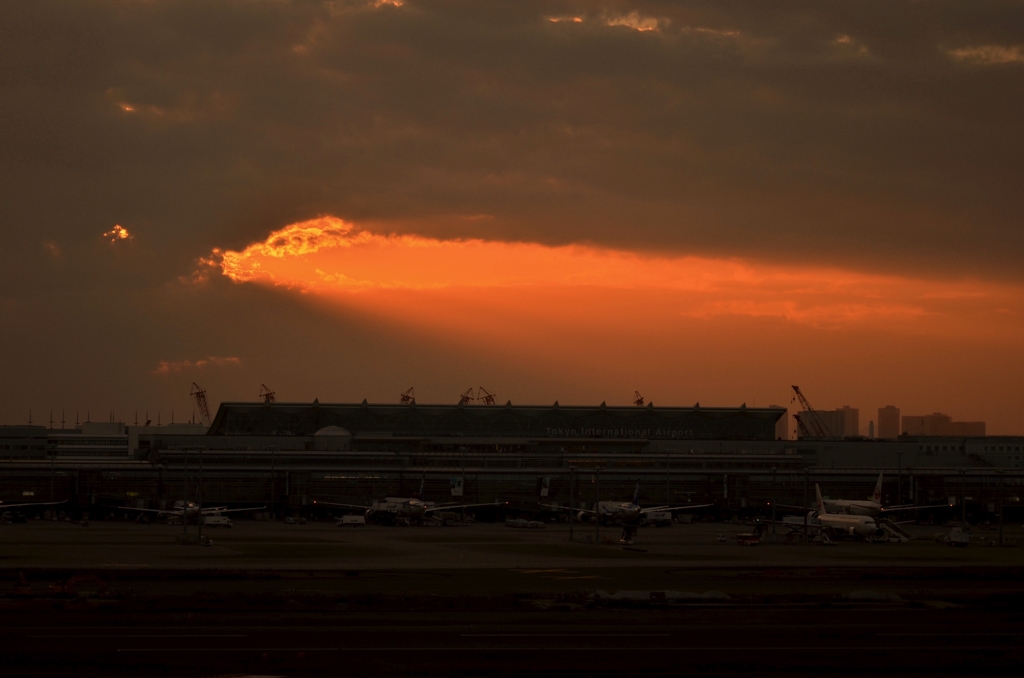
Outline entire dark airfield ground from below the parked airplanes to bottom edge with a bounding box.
[0,524,1024,678]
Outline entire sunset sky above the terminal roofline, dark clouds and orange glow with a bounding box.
[0,0,1024,434]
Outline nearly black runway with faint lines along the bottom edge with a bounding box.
[0,604,1024,677]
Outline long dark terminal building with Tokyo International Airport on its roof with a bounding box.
[0,400,1024,518]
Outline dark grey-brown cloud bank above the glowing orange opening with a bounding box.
[0,0,1024,430]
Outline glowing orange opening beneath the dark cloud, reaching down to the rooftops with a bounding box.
[203,217,1024,431]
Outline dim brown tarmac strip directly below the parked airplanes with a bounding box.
[0,520,1024,570]
